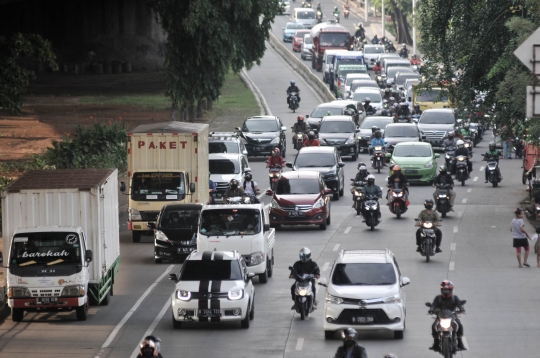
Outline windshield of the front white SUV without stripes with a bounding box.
[332,263,396,286]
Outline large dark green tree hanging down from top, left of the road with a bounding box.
[151,0,280,121]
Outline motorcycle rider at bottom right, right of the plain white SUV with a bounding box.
[429,280,467,351]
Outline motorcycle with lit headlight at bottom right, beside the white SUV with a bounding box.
[426,300,467,358]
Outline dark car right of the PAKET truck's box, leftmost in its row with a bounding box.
[236,116,287,157]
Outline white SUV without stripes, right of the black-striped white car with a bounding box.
[319,249,411,339]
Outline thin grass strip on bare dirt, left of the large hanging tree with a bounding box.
[79,93,171,110]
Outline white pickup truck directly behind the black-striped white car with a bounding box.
[197,204,276,283]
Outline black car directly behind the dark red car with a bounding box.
[287,147,345,200]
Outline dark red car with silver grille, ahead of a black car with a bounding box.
[266,171,332,230]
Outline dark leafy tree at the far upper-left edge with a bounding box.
[0,33,58,113]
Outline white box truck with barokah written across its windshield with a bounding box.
[0,169,120,322]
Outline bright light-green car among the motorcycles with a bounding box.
[386,142,440,184]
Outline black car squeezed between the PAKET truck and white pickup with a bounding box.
[148,204,202,263]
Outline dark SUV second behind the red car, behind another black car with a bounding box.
[319,116,360,160]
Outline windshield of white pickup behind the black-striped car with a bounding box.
[200,209,261,236]
